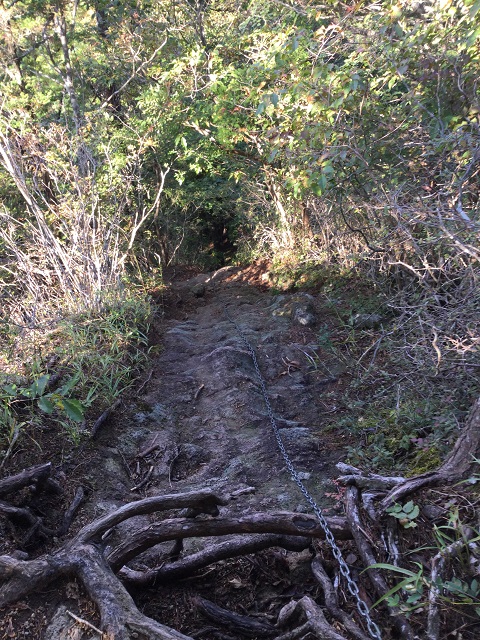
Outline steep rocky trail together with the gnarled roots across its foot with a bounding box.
[0,266,480,640]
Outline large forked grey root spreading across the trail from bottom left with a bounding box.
[0,490,348,640]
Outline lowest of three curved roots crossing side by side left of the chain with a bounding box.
[118,534,311,587]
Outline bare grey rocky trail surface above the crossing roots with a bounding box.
[92,268,341,528]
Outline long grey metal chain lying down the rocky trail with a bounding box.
[224,305,382,640]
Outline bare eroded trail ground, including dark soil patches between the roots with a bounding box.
[0,268,356,639]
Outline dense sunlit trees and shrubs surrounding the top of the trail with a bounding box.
[0,0,480,636]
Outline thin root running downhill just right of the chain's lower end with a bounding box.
[345,486,414,640]
